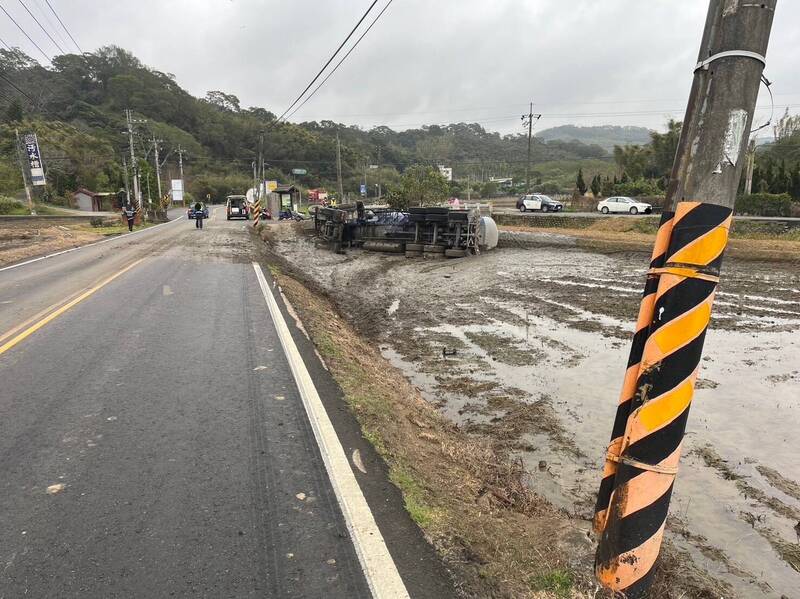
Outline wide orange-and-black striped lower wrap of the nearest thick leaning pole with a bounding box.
[595,202,732,599]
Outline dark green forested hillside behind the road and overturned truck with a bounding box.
[0,46,608,202]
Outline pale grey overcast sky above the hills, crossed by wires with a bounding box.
[0,0,800,133]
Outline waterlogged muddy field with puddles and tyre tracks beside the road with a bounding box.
[273,227,800,599]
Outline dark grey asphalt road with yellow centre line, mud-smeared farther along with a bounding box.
[0,208,453,599]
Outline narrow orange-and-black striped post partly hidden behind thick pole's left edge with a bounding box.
[594,211,675,533]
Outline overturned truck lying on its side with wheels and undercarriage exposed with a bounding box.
[314,202,498,258]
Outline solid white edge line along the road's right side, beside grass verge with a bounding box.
[253,262,409,599]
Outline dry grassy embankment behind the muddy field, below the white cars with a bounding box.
[500,216,800,262]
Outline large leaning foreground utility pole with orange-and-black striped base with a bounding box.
[595,0,777,599]
